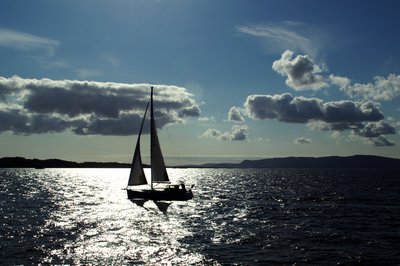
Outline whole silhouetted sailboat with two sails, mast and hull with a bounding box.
[126,86,193,201]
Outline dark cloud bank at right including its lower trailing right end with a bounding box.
[243,93,396,146]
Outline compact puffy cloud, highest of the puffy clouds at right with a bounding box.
[272,50,328,91]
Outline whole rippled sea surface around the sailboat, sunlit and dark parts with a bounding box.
[0,169,400,265]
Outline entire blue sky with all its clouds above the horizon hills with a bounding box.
[0,0,400,165]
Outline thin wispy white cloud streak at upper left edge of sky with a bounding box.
[0,28,60,56]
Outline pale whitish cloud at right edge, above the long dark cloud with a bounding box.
[342,74,400,101]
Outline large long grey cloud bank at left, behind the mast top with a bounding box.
[0,76,200,135]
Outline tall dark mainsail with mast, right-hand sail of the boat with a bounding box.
[150,87,169,187]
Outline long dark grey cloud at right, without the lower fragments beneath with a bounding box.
[244,93,384,123]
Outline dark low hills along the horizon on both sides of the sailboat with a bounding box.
[0,155,400,169]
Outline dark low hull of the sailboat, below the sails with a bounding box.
[126,189,193,201]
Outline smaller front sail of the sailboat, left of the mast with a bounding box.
[128,103,149,186]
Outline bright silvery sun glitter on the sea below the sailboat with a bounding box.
[45,169,208,264]
